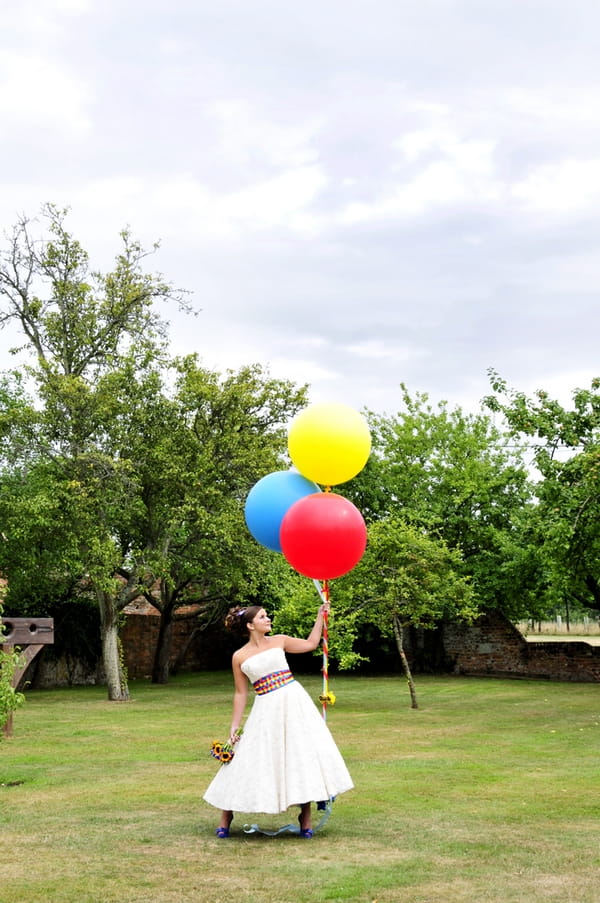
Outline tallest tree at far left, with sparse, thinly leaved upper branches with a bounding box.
[0,205,185,700]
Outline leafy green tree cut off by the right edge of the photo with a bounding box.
[485,371,600,612]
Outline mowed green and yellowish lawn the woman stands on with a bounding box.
[0,672,600,903]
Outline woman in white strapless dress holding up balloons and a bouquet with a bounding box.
[204,603,354,838]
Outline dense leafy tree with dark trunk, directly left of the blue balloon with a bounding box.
[115,356,306,683]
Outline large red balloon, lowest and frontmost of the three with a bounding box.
[280,492,367,580]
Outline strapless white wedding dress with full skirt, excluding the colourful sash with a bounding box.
[204,647,354,814]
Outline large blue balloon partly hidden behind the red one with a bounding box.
[244,470,319,552]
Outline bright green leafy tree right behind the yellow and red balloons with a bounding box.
[347,386,531,614]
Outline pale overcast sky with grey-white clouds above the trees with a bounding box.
[0,0,600,413]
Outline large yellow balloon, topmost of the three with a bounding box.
[288,402,371,486]
